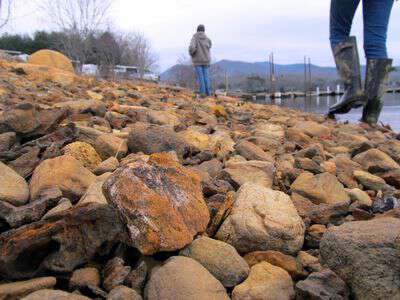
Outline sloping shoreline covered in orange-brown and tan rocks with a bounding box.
[0,54,400,300]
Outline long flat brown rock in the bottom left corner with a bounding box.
[0,277,57,300]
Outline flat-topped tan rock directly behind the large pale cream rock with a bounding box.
[218,161,275,188]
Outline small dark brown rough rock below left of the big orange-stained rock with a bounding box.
[103,257,131,292]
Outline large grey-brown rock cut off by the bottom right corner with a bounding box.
[320,218,400,299]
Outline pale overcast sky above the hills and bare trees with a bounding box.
[3,0,400,71]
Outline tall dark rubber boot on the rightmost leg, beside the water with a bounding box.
[361,59,393,125]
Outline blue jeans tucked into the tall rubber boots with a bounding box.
[330,0,394,59]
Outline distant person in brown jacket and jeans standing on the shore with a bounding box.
[189,25,212,97]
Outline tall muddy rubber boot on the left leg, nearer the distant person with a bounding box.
[328,36,365,117]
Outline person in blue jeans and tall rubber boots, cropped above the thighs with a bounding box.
[329,0,394,124]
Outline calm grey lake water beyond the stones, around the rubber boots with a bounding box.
[257,93,400,132]
